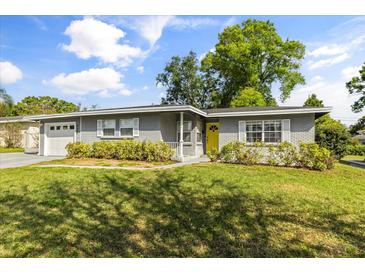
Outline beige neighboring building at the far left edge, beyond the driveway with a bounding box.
[0,116,39,153]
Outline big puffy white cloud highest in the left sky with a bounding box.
[62,18,143,66]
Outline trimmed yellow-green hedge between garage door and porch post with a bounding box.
[66,140,172,162]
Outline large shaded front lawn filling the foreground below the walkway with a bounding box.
[0,163,365,257]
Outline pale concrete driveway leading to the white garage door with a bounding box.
[0,152,64,168]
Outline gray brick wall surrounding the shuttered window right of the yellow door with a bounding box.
[219,114,314,149]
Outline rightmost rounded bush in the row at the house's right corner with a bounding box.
[299,144,334,170]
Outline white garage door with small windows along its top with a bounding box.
[45,123,76,156]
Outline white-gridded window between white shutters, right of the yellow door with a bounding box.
[246,120,282,143]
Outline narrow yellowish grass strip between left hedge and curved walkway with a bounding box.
[36,158,175,168]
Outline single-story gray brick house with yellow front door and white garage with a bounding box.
[29,105,331,161]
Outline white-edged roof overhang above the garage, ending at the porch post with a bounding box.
[28,106,206,121]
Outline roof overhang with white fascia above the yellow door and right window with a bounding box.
[206,107,332,118]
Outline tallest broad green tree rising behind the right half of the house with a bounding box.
[202,19,305,107]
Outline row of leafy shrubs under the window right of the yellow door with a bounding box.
[208,141,334,170]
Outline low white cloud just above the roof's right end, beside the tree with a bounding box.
[283,76,365,124]
